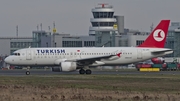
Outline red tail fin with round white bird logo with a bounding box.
[138,20,170,48]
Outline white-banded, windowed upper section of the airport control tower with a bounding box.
[89,4,117,36]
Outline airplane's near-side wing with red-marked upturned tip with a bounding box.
[66,53,121,65]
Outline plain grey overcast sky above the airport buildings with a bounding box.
[0,0,180,37]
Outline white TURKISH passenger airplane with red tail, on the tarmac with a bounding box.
[5,20,173,75]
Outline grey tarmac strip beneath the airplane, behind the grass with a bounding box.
[0,69,180,76]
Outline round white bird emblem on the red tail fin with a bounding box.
[153,29,165,41]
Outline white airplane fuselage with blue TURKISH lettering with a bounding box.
[5,47,173,66]
